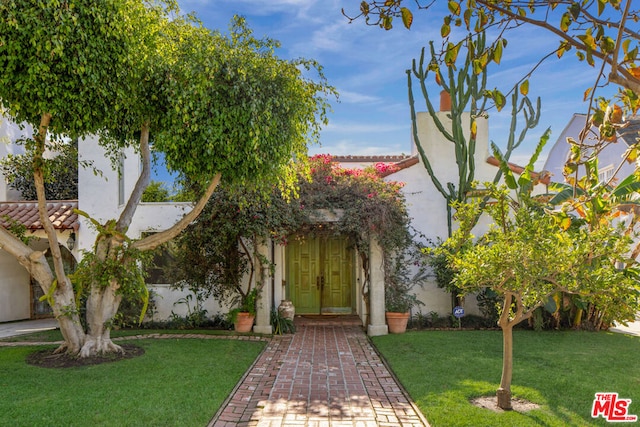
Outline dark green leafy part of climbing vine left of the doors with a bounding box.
[168,185,299,313]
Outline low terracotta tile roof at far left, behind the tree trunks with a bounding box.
[0,200,80,231]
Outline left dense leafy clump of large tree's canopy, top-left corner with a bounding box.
[0,0,134,137]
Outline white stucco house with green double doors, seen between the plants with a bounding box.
[0,98,544,335]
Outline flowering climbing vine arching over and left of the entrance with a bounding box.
[170,155,417,318]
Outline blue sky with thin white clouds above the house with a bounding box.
[179,0,616,164]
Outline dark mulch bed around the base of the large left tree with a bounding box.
[26,344,144,368]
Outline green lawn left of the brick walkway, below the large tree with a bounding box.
[0,331,264,426]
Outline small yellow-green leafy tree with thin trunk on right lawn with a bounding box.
[442,139,640,409]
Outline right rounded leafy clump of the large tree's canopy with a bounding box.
[154,18,333,188]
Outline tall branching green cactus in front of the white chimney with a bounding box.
[407,33,540,236]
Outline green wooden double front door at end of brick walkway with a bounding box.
[286,237,353,314]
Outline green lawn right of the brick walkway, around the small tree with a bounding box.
[373,331,640,427]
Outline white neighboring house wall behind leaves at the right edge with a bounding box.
[543,114,637,182]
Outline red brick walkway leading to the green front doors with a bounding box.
[209,319,428,427]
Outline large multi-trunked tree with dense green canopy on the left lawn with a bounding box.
[0,0,333,356]
